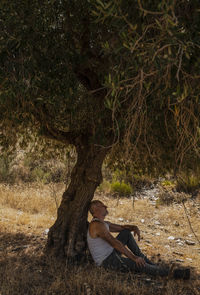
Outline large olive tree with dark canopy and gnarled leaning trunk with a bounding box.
[0,0,200,257]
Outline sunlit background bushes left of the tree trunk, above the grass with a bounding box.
[0,149,76,184]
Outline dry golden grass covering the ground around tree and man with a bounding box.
[0,184,200,295]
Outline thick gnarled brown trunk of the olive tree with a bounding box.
[47,145,108,258]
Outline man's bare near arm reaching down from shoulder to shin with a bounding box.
[95,222,145,266]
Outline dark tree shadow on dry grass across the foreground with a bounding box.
[0,233,200,295]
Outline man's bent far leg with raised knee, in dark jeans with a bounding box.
[116,229,154,265]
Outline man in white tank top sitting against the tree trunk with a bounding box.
[87,200,190,279]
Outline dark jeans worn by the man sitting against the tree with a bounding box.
[102,229,169,276]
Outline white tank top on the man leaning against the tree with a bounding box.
[87,218,114,265]
